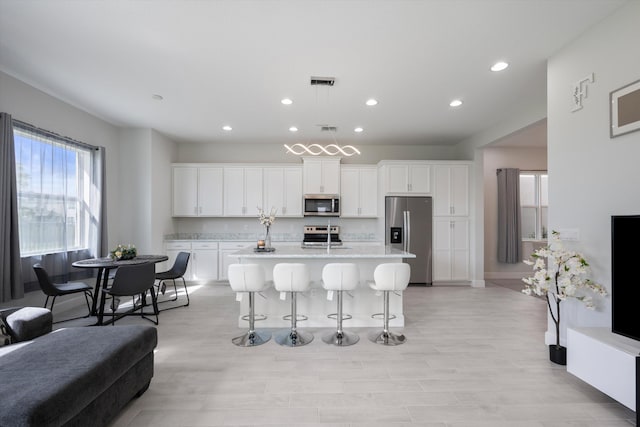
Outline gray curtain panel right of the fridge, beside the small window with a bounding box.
[496,168,522,264]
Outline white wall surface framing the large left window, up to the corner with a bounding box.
[0,72,120,251]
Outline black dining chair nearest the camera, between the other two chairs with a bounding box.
[98,263,158,325]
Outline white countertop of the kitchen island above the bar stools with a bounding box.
[232,244,416,259]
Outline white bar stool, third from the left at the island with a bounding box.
[322,263,360,346]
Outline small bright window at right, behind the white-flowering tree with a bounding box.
[520,171,549,240]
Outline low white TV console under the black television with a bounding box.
[567,328,640,425]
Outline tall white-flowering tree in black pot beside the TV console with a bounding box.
[522,231,607,365]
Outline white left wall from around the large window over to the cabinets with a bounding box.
[0,72,177,253]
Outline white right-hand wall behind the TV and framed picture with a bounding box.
[546,1,640,342]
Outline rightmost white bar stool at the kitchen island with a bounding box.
[369,263,411,345]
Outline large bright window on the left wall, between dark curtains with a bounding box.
[14,123,95,257]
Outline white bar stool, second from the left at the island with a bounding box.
[273,263,313,347]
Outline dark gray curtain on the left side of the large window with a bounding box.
[0,113,24,302]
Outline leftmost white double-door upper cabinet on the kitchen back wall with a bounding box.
[172,165,223,216]
